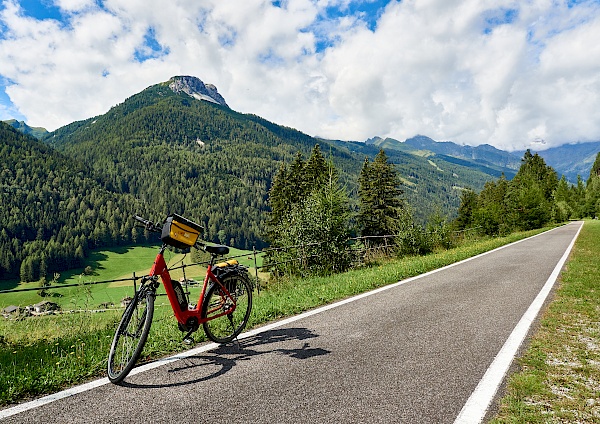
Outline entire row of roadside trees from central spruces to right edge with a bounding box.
[265,145,600,275]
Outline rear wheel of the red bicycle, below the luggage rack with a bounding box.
[202,274,252,343]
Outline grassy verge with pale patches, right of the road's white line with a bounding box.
[491,221,600,424]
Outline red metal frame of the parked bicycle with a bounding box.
[149,245,237,326]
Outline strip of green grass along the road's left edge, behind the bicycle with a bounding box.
[0,230,542,405]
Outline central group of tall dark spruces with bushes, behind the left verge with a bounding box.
[265,144,452,275]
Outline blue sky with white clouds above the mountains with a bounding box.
[0,0,600,151]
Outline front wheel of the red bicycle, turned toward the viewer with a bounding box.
[108,289,154,384]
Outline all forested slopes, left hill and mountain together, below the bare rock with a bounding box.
[0,79,504,280]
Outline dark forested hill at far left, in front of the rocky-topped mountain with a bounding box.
[0,123,145,281]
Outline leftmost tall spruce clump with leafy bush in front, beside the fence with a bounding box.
[266,144,350,274]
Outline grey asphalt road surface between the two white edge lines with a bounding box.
[3,223,581,423]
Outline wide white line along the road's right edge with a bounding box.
[454,222,583,424]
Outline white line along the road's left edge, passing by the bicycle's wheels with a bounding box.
[0,224,581,423]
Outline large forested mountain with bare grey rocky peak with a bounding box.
[44,76,502,243]
